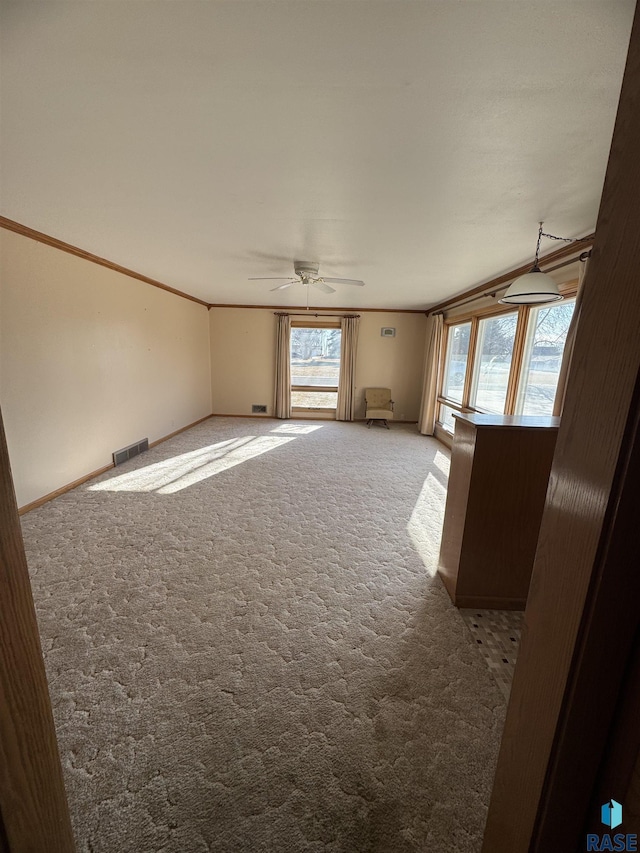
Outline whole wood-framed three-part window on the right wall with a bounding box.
[438,282,577,433]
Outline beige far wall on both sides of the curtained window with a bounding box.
[209,308,426,421]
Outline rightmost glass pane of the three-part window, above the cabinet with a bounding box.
[516,299,576,415]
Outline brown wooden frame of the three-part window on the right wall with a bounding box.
[436,279,578,439]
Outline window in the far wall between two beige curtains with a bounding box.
[291,324,342,411]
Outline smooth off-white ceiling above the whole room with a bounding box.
[0,0,634,308]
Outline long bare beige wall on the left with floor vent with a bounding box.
[0,229,211,506]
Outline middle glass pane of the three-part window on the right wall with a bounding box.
[470,311,518,415]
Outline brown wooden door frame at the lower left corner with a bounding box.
[0,412,75,853]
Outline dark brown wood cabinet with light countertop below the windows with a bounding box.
[438,414,559,610]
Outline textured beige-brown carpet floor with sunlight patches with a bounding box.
[23,418,504,853]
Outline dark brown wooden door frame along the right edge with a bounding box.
[483,1,640,853]
